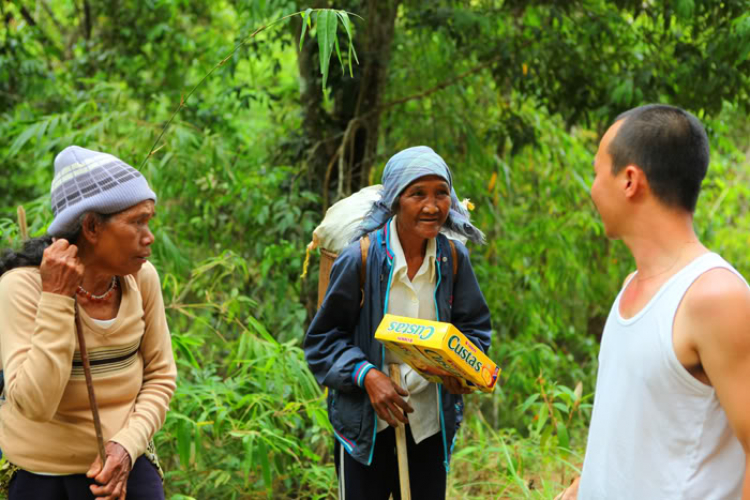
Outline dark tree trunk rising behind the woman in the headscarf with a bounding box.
[295,0,400,210]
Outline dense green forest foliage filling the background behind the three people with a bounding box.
[0,0,750,499]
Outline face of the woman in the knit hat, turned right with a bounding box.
[94,200,156,276]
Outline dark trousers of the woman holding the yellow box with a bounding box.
[334,425,446,500]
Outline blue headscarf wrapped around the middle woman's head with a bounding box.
[357,146,484,244]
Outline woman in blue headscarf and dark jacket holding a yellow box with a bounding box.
[304,146,491,500]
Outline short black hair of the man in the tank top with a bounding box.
[609,104,709,213]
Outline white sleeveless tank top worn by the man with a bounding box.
[578,253,745,500]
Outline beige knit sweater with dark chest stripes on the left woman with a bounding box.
[0,263,177,474]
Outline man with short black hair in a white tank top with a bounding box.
[558,105,750,500]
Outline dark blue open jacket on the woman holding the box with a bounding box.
[303,224,491,470]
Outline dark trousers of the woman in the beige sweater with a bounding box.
[8,456,164,500]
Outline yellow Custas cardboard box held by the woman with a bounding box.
[375,314,500,392]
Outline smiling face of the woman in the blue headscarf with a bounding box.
[396,175,451,238]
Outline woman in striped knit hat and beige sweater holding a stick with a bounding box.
[0,146,176,500]
